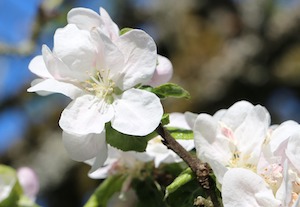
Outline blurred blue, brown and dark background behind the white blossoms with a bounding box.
[0,0,300,207]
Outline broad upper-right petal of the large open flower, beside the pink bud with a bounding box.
[115,29,157,90]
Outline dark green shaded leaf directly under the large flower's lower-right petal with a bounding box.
[105,123,157,152]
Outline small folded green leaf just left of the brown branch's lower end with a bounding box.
[165,168,195,198]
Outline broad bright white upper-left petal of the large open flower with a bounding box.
[53,24,98,80]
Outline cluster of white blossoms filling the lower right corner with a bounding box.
[193,101,300,207]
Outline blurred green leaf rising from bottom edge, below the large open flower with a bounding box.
[84,175,126,207]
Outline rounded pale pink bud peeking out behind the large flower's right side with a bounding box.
[148,55,173,87]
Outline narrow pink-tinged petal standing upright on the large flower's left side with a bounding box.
[42,45,72,80]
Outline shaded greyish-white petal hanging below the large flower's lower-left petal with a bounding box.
[63,131,106,162]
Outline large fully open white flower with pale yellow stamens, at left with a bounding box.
[28,11,163,168]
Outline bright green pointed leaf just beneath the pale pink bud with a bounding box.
[152,83,191,99]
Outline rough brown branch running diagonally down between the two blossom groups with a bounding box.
[156,124,220,207]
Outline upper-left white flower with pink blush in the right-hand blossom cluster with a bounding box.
[193,101,270,184]
